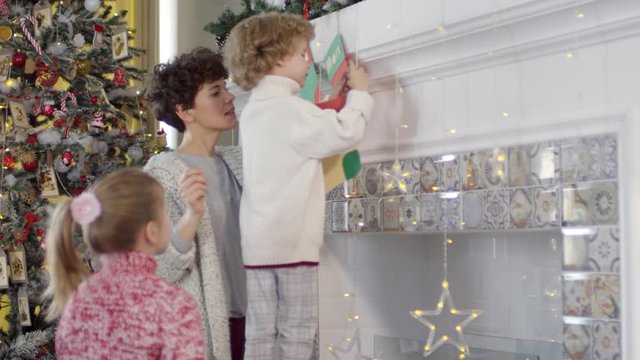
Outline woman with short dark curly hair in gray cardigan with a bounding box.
[145,47,247,360]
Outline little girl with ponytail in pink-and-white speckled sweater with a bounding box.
[46,169,204,359]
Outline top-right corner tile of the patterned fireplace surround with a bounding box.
[587,135,618,180]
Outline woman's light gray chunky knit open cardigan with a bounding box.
[144,146,242,360]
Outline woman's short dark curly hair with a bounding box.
[147,47,228,132]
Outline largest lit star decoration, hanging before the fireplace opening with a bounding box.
[411,280,482,359]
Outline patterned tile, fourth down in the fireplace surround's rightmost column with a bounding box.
[591,275,620,319]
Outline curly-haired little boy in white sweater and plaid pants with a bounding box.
[225,13,373,360]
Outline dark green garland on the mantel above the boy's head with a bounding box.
[204,0,362,48]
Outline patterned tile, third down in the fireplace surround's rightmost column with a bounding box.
[588,227,620,273]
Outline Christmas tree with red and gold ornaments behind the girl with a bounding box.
[0,0,165,359]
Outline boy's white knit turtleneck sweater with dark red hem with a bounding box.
[240,75,373,266]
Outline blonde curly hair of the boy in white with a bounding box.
[224,12,315,91]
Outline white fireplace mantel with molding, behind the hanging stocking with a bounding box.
[233,0,640,360]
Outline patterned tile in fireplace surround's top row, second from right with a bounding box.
[560,138,591,183]
